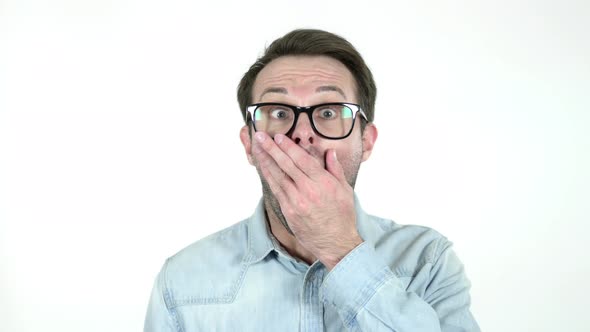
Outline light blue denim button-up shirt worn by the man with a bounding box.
[144,197,479,332]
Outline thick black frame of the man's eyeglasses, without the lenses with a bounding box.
[246,103,368,140]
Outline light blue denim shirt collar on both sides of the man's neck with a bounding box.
[246,193,378,264]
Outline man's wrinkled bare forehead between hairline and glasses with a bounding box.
[252,56,356,103]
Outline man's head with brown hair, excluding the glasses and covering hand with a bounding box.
[238,30,377,235]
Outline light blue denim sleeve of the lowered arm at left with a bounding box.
[143,265,180,332]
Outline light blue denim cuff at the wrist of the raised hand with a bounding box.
[320,242,397,325]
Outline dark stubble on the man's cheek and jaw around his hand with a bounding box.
[256,148,362,236]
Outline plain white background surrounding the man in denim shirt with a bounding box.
[0,0,590,331]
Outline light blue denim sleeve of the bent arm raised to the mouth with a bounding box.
[321,241,480,332]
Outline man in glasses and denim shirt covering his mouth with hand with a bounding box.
[145,30,479,332]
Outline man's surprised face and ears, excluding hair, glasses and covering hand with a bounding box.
[241,56,376,230]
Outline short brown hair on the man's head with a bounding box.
[238,29,377,127]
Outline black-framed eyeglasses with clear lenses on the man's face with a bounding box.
[246,103,367,139]
